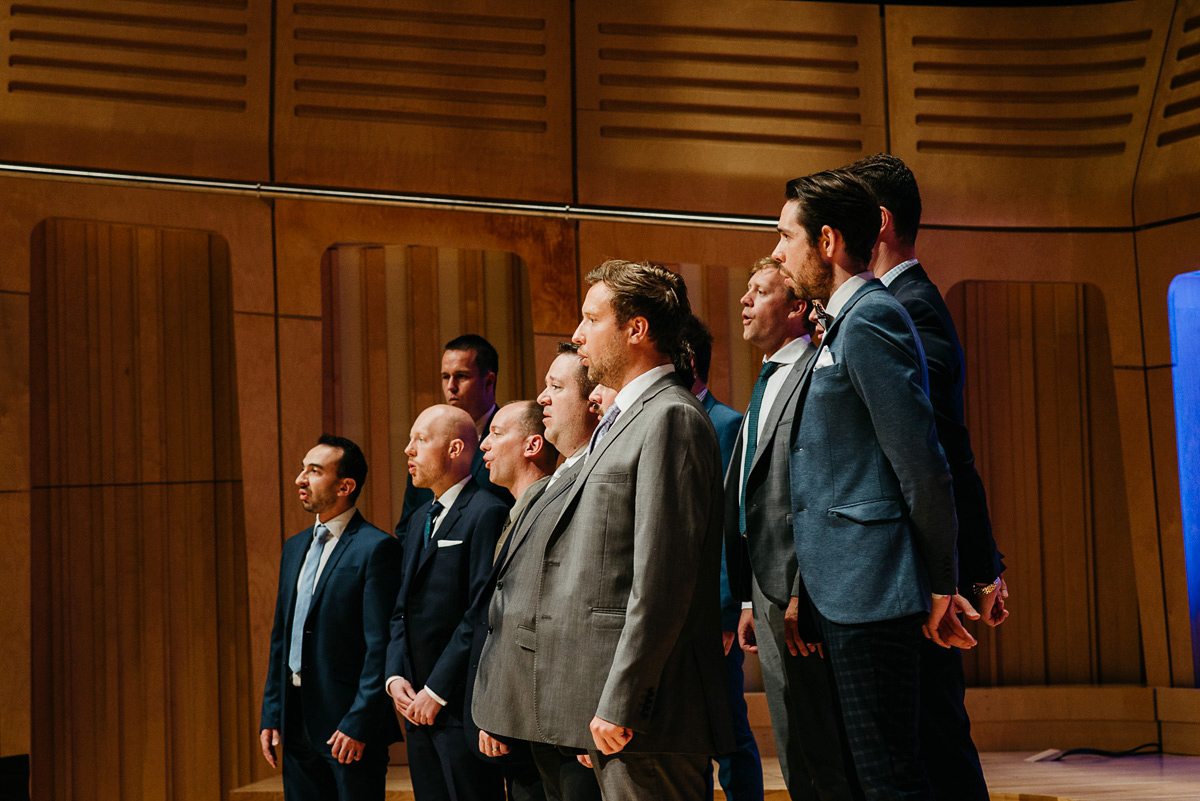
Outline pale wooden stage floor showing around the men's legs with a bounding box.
[229,752,1200,801]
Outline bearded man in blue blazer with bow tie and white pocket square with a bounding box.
[773,170,958,801]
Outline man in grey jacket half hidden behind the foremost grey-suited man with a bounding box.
[472,342,600,801]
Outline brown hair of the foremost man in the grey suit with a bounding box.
[587,259,691,356]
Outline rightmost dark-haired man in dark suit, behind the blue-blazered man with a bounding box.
[846,153,1008,801]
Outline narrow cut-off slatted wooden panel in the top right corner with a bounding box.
[1134,0,1200,225]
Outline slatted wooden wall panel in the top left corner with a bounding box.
[0,0,271,180]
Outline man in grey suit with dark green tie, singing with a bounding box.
[725,257,858,801]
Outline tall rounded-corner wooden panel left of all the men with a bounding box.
[29,218,258,801]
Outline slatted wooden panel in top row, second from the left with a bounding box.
[275,0,571,201]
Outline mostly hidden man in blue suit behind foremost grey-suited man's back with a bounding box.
[677,314,763,801]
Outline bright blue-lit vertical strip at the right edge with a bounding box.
[1166,272,1200,680]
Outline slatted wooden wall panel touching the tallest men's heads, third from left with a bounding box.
[575,0,886,216]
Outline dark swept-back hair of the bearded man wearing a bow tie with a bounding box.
[786,169,880,265]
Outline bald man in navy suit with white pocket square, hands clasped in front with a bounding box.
[385,404,508,801]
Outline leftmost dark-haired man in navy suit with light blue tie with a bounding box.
[259,435,401,801]
